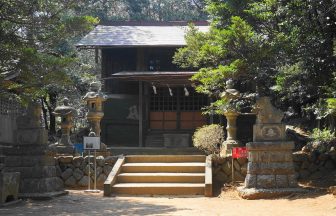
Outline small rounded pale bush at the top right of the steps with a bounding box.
[193,124,224,155]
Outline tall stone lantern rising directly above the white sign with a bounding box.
[83,82,106,136]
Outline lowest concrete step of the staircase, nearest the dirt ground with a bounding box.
[112,183,205,195]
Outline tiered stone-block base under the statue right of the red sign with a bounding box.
[245,141,298,189]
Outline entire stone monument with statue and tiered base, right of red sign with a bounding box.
[238,97,303,199]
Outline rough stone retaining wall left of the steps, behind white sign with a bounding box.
[56,156,118,189]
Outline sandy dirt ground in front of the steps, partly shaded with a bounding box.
[0,187,336,216]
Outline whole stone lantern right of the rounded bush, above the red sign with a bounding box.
[221,79,240,156]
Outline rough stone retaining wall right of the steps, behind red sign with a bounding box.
[212,151,336,184]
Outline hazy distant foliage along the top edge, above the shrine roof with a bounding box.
[74,0,206,22]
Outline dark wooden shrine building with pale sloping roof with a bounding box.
[77,22,255,147]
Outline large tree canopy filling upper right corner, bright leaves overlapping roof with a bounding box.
[175,0,336,126]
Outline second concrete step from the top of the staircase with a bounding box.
[122,162,205,173]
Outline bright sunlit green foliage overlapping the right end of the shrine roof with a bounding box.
[174,11,274,112]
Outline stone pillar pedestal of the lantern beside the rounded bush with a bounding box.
[221,111,240,157]
